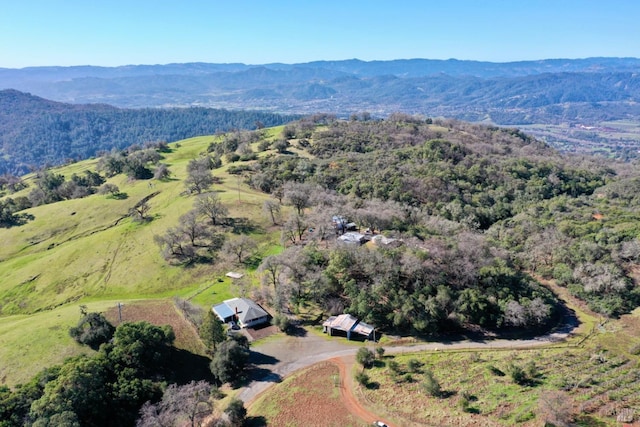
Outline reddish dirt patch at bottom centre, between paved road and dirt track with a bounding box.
[249,362,369,427]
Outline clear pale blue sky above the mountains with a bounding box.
[0,0,640,68]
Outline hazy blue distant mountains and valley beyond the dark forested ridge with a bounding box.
[0,58,640,125]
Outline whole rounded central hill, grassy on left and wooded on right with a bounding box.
[0,115,640,388]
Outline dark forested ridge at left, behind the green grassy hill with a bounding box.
[0,90,292,175]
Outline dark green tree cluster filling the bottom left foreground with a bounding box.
[0,306,249,427]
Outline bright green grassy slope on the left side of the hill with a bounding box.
[0,128,281,385]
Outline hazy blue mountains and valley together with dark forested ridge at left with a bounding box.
[0,58,640,171]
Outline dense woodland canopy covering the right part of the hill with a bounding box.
[224,118,640,332]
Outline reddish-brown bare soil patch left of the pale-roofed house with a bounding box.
[104,300,204,354]
